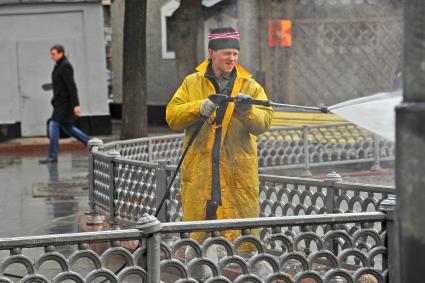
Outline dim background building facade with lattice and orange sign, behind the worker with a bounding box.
[111,0,403,114]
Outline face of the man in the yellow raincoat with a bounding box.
[208,48,239,77]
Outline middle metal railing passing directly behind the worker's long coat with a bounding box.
[160,168,395,225]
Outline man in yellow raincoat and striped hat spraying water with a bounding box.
[166,28,273,246]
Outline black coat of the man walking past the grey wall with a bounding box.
[51,56,80,123]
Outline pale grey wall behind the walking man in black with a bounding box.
[0,2,109,136]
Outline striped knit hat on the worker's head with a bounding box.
[208,28,239,50]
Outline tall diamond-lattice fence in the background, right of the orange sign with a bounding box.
[260,0,403,105]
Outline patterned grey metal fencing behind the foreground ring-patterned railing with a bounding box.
[90,123,395,224]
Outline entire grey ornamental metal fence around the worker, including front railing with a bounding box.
[0,124,395,283]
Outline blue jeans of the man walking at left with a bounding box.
[49,120,90,159]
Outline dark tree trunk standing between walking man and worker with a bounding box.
[121,0,148,139]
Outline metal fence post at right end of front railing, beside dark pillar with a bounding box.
[378,197,401,283]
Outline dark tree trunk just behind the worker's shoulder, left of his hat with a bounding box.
[171,0,202,80]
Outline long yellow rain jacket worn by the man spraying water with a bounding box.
[166,60,273,243]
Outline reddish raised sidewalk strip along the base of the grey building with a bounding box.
[0,120,175,154]
